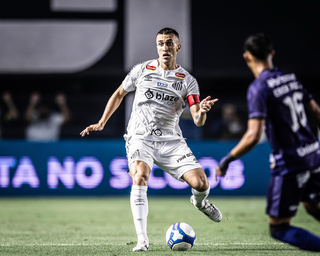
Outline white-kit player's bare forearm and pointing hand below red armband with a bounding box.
[190,96,218,127]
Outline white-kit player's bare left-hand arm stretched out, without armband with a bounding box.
[80,85,128,137]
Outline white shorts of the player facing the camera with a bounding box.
[126,139,202,181]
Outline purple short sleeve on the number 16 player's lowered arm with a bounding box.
[247,84,267,119]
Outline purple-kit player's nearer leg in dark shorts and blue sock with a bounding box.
[267,173,320,251]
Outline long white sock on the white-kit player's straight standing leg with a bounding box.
[130,185,149,241]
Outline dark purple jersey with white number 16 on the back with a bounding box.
[247,68,320,174]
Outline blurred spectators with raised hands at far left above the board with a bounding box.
[0,91,70,142]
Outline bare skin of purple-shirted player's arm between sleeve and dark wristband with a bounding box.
[230,118,265,158]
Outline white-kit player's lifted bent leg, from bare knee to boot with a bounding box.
[182,168,222,222]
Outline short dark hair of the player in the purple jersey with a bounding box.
[244,33,273,60]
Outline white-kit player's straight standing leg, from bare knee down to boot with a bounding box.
[130,161,151,251]
